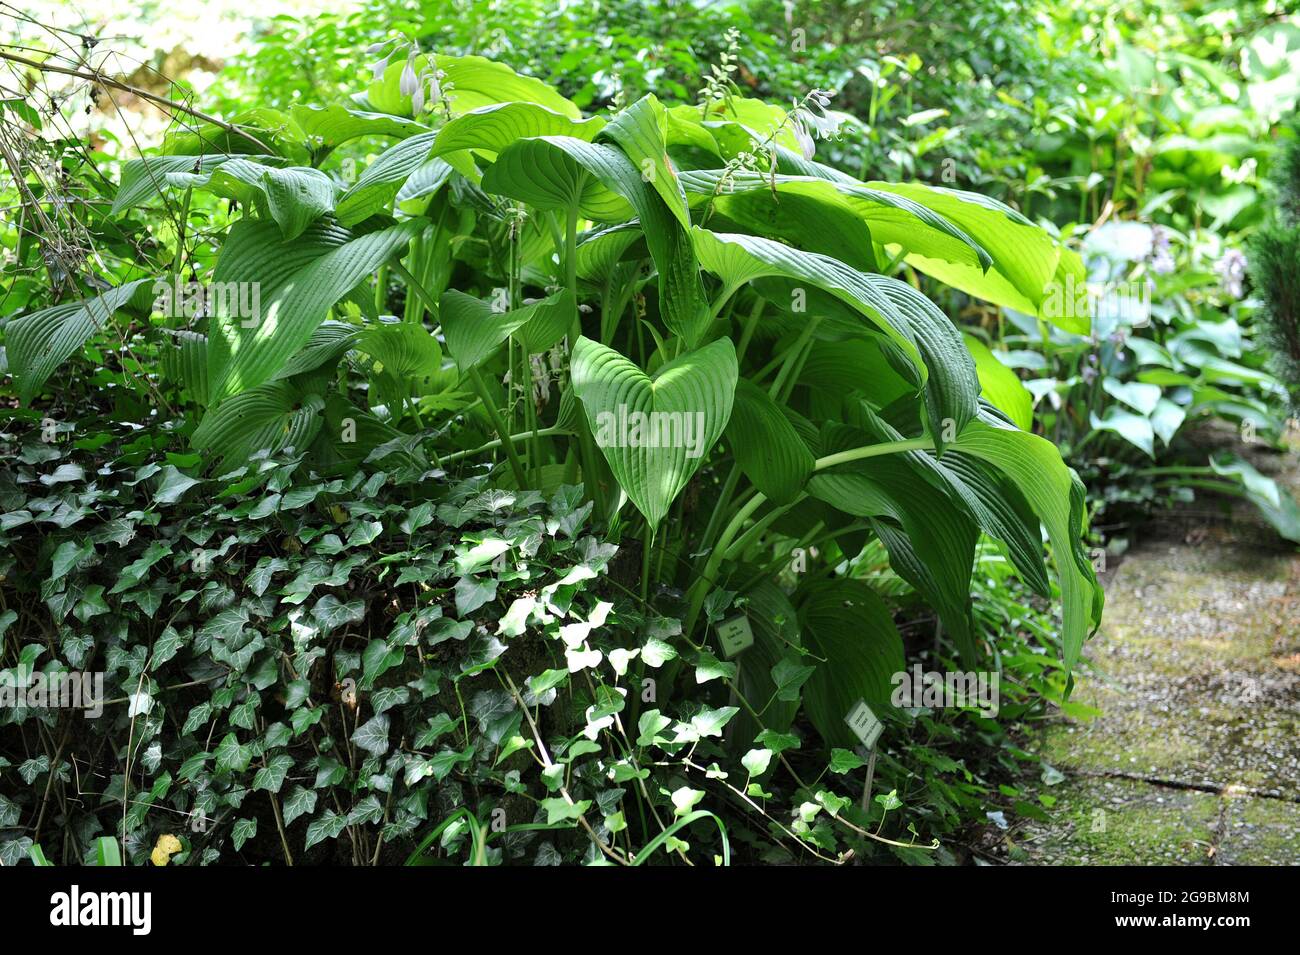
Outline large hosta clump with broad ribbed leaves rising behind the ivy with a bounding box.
[5,44,1102,851]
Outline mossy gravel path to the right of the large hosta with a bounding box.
[1004,441,1300,865]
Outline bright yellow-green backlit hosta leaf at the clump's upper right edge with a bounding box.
[867,182,1091,335]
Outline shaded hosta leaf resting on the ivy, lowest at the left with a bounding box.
[191,381,325,466]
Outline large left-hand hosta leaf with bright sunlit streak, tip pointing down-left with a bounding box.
[208,220,425,403]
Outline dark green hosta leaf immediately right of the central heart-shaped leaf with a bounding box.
[727,378,813,504]
